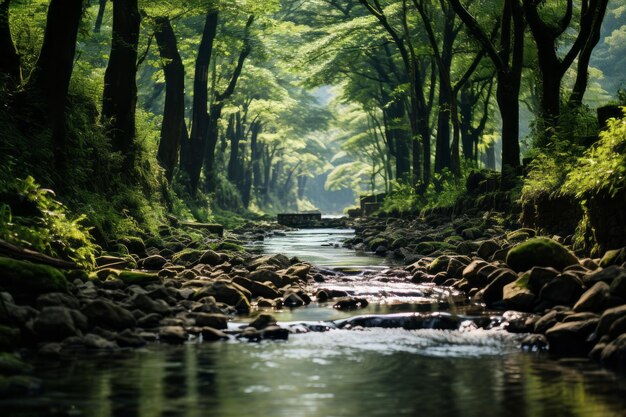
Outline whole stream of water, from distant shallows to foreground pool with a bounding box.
[0,230,626,417]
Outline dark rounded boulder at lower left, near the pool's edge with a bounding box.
[33,306,87,341]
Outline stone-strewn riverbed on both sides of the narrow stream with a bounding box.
[0,215,626,396]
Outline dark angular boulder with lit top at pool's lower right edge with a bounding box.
[546,319,599,356]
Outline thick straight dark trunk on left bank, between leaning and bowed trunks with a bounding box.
[102,0,141,171]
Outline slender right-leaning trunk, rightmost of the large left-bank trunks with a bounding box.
[181,10,218,196]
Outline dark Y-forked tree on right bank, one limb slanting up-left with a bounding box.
[450,0,526,174]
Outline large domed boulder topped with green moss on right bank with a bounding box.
[506,237,578,272]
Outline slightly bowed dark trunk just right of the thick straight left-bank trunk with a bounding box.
[154,17,187,181]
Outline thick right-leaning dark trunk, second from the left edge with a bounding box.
[27,0,83,169]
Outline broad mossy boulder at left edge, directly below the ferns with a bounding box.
[0,257,67,298]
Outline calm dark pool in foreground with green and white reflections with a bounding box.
[0,331,626,417]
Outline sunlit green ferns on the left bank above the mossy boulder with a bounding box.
[0,177,99,268]
